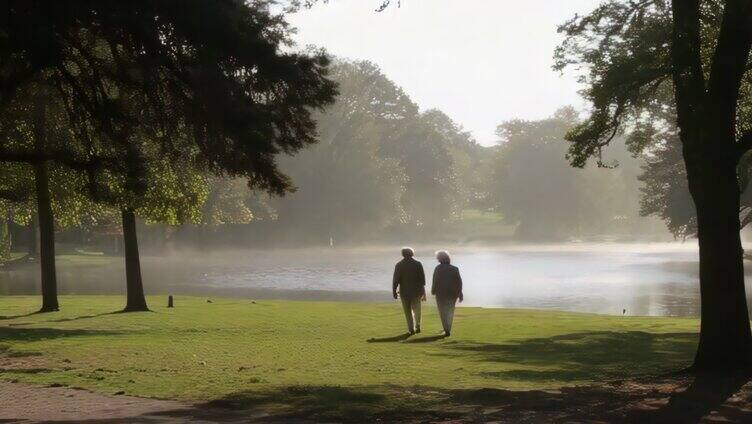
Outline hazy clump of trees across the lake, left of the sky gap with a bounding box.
[273,61,481,240]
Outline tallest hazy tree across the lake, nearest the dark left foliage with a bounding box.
[274,61,408,242]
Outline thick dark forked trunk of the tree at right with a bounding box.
[671,0,752,371]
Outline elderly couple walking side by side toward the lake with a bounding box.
[392,247,464,337]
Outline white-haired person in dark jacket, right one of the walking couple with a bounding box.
[431,250,463,337]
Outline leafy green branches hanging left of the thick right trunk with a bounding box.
[554,0,672,167]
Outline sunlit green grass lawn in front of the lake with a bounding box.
[0,296,698,418]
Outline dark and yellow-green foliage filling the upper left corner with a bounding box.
[0,0,336,238]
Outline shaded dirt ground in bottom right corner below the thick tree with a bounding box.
[444,375,752,423]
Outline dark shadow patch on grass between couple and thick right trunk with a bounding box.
[439,331,697,383]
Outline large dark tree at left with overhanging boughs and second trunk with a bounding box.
[0,0,336,310]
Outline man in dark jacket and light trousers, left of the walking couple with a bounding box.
[392,247,426,334]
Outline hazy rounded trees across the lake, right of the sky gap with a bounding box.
[488,108,638,239]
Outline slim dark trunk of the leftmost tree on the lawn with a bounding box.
[34,162,59,312]
